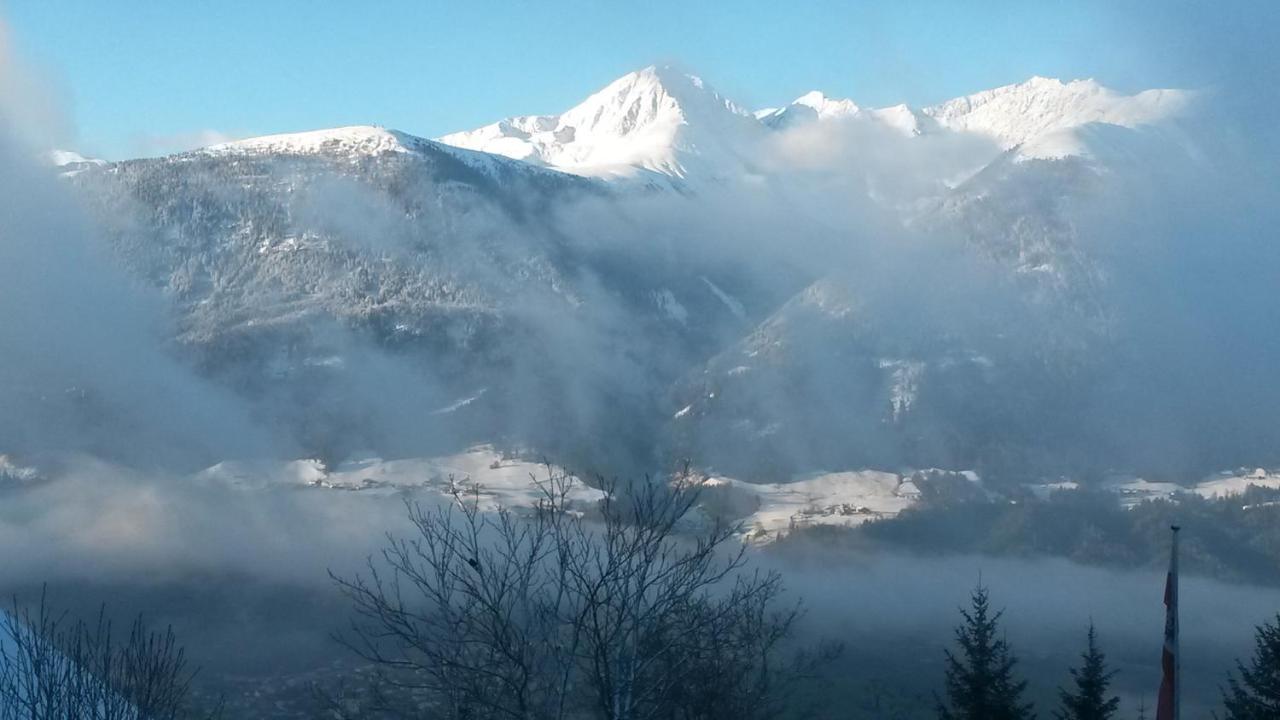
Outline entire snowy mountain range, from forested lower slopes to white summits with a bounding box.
[47,67,1228,479]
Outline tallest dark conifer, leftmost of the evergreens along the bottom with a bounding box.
[938,583,1036,720]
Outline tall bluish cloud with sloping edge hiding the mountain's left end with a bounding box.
[0,37,271,466]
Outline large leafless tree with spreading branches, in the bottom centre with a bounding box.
[335,461,819,720]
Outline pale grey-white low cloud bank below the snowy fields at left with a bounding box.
[0,457,404,579]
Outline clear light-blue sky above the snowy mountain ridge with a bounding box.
[0,0,1249,159]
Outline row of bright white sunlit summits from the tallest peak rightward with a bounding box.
[439,67,1192,181]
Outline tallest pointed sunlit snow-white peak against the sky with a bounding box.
[440,65,762,178]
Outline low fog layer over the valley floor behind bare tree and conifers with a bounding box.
[0,464,1280,714]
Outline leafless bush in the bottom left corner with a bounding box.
[0,596,209,720]
